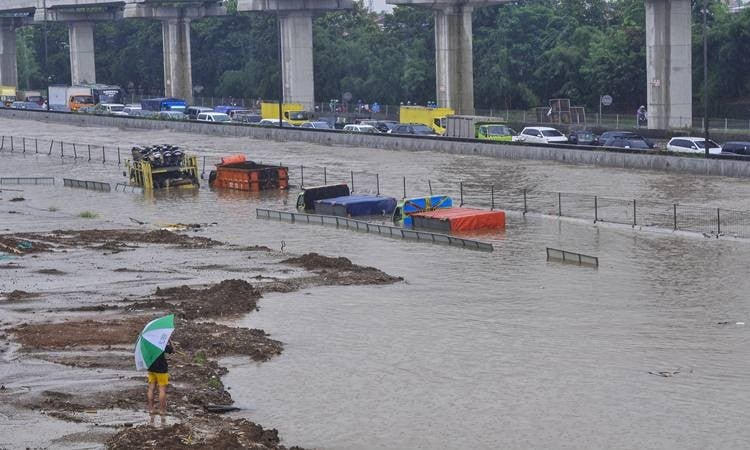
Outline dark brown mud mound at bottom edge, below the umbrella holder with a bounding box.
[106,415,303,450]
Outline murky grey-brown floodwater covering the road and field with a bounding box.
[0,120,750,449]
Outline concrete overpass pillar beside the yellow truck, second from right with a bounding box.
[435,5,474,114]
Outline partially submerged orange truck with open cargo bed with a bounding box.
[208,155,289,192]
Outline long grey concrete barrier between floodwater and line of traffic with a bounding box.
[0,108,750,178]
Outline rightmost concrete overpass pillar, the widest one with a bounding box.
[648,0,693,129]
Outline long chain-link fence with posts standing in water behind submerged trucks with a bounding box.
[0,136,750,238]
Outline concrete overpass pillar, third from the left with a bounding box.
[161,17,193,104]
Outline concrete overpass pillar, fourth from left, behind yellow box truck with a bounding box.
[279,10,315,111]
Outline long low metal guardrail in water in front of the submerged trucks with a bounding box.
[255,208,494,252]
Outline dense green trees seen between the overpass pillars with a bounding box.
[17,0,750,115]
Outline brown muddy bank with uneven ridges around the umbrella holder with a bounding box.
[0,230,402,449]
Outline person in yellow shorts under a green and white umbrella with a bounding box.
[135,314,174,416]
